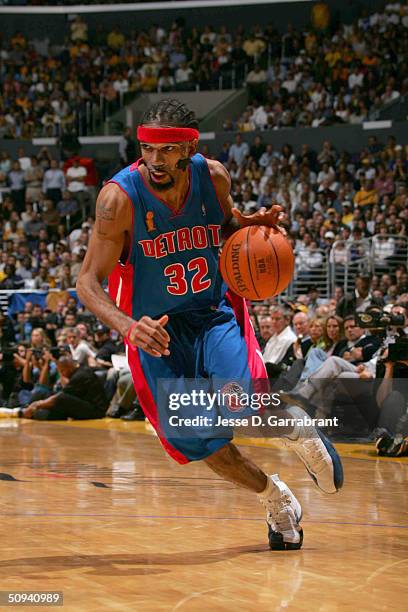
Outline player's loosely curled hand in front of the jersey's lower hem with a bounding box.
[126,315,170,357]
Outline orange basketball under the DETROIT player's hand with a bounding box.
[220,225,295,300]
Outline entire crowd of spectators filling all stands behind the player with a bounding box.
[0,5,408,444]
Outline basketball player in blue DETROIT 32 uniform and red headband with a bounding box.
[77,99,342,549]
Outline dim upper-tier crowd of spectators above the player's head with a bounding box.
[0,4,408,138]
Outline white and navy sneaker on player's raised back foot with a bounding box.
[281,406,343,493]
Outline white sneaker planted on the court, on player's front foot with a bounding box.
[259,474,303,550]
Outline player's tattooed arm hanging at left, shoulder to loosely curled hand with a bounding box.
[77,183,170,357]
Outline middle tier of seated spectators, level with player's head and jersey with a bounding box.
[0,130,408,296]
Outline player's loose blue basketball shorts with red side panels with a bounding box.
[127,292,267,463]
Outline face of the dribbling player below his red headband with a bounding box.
[140,142,189,191]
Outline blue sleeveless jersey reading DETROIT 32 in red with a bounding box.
[108,154,227,319]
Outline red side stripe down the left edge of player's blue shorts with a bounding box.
[125,339,189,464]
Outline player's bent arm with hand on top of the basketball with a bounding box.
[208,160,284,238]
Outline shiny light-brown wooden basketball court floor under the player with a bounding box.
[0,419,408,612]
